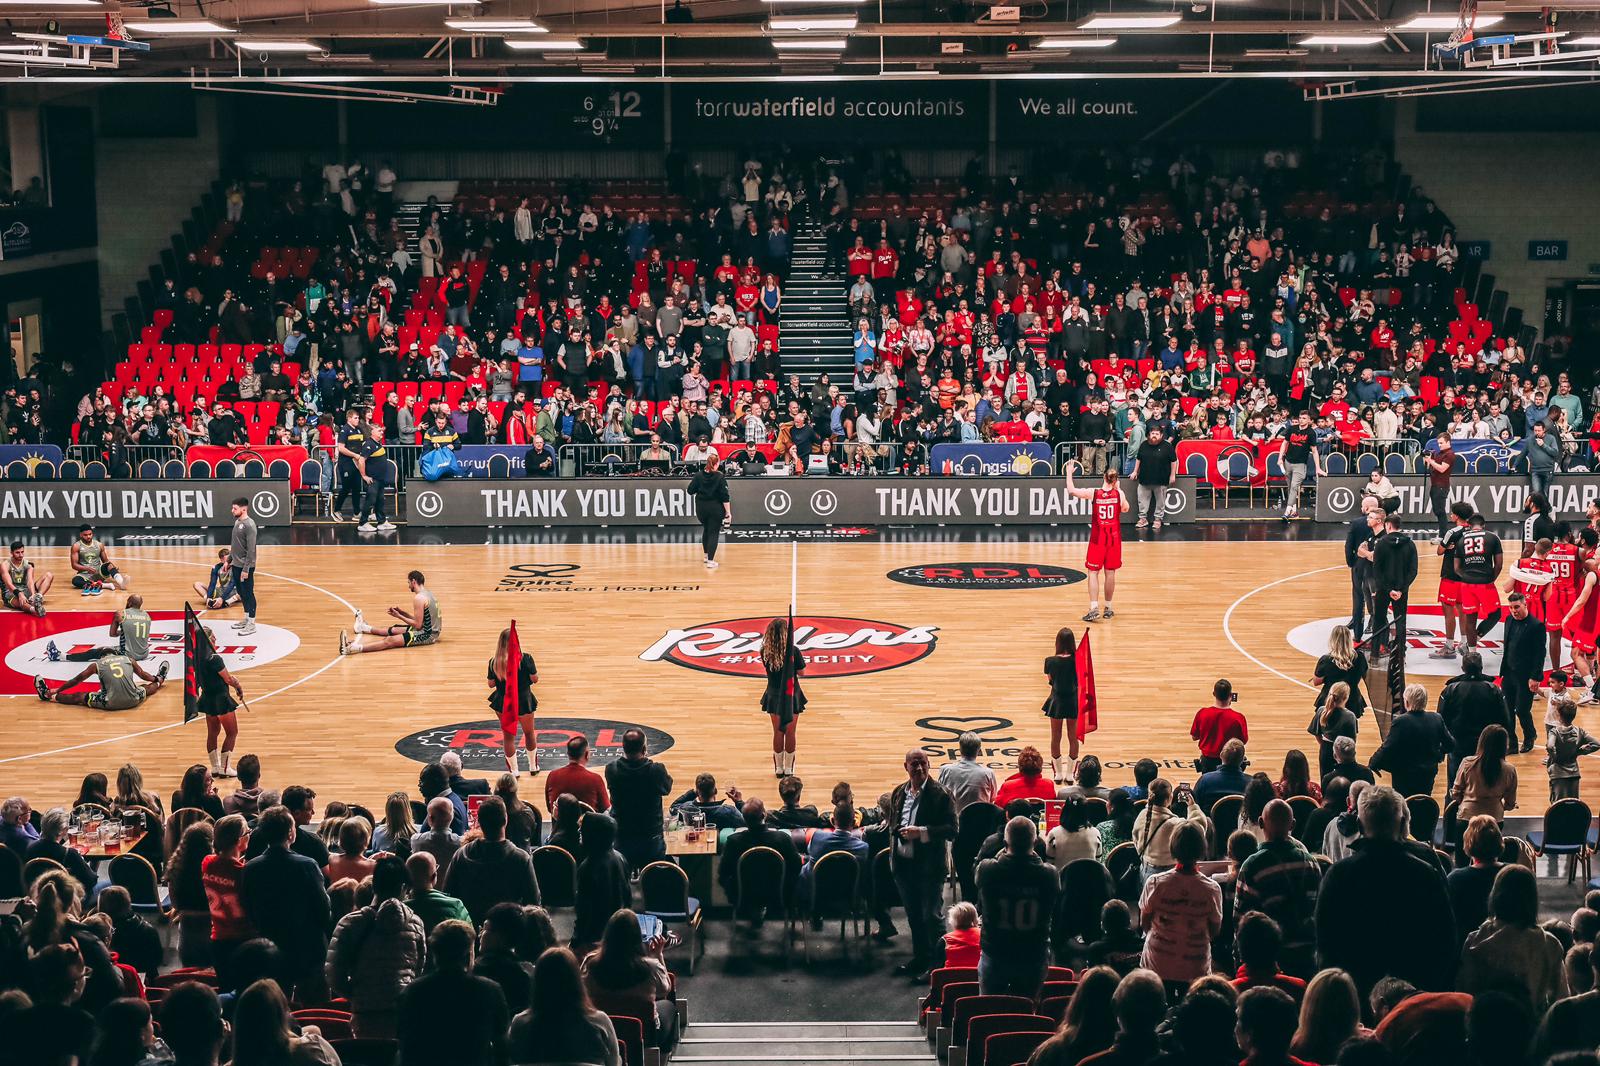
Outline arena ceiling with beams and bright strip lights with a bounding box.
[0,0,1600,82]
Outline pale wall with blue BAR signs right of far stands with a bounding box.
[1395,93,1600,335]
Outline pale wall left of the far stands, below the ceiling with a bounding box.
[94,93,221,330]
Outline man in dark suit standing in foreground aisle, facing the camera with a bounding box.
[890,749,955,981]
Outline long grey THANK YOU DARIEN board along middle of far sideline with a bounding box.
[406,477,1195,528]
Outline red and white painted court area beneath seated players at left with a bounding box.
[0,611,299,696]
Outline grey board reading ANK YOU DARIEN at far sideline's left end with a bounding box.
[0,479,293,533]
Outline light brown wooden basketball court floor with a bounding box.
[0,538,1574,813]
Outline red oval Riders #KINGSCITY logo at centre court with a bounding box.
[638,615,939,679]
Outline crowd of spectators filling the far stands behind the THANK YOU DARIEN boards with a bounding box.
[6,140,1600,472]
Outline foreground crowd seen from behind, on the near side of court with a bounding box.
[9,671,1600,1066]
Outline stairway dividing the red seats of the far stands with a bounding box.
[778,219,854,387]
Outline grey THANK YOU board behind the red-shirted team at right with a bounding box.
[1317,474,1600,527]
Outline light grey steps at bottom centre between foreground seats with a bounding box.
[672,1017,938,1066]
